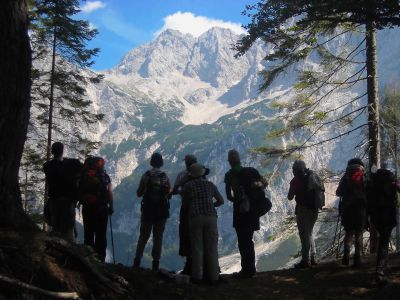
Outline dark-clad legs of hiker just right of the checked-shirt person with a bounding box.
[235,226,256,275]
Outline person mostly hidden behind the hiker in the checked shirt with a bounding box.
[172,154,197,275]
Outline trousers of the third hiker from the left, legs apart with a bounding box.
[135,218,167,261]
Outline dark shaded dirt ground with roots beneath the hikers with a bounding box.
[0,229,400,300]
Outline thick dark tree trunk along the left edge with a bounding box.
[0,0,32,228]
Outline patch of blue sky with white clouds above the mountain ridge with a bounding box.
[77,0,255,70]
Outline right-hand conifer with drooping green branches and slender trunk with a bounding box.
[236,0,400,170]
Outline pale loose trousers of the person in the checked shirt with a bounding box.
[189,215,219,281]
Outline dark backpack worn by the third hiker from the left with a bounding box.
[142,171,170,220]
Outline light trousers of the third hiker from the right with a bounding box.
[296,205,318,261]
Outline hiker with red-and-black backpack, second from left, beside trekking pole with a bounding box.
[79,157,114,261]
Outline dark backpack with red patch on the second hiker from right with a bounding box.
[342,164,367,207]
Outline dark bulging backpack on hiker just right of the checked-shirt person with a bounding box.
[239,167,272,217]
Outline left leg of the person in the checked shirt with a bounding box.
[190,216,208,280]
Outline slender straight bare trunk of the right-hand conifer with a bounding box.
[366,21,381,170]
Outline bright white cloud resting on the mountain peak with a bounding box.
[154,11,245,37]
